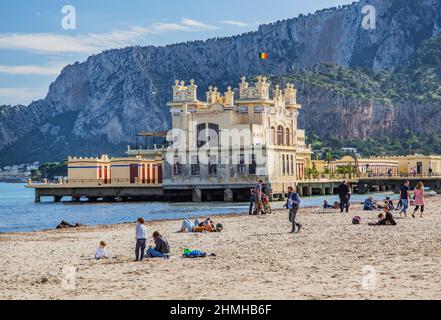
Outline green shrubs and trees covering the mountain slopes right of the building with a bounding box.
[273,35,441,156]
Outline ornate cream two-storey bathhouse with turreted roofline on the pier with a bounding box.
[163,76,311,201]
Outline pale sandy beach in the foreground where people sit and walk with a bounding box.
[0,196,441,299]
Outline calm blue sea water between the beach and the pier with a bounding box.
[0,183,394,232]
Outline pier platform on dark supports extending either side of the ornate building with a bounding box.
[27,176,441,202]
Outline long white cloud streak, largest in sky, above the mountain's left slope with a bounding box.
[0,18,218,54]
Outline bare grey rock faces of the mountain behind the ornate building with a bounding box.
[0,0,441,164]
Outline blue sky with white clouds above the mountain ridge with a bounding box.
[0,0,354,105]
